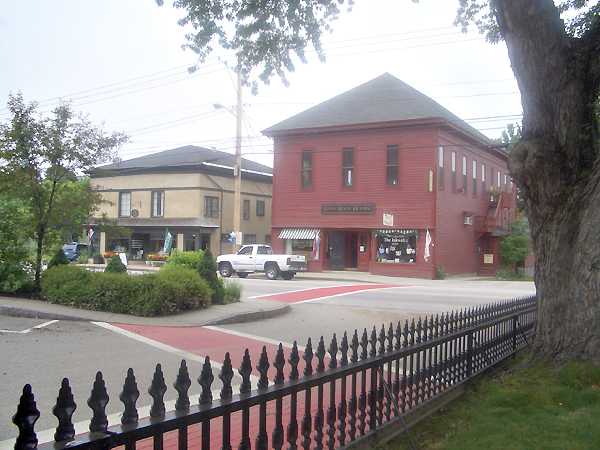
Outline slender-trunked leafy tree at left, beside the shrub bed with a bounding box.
[0,93,127,292]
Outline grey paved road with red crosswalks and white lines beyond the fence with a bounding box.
[0,278,534,449]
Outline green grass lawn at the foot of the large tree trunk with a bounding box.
[385,356,600,450]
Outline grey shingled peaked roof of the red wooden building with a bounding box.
[262,73,490,143]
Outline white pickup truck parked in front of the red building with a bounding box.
[217,244,306,280]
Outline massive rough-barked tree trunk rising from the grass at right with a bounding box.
[495,0,600,364]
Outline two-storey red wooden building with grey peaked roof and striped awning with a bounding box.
[263,73,516,278]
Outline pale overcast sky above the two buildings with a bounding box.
[0,0,522,166]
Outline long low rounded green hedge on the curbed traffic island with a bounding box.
[41,266,211,317]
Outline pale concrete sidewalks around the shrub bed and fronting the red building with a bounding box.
[0,265,440,327]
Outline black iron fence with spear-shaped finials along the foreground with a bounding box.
[13,297,536,450]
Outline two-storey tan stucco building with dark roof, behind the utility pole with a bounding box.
[90,145,273,259]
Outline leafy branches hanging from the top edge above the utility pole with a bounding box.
[156,0,354,91]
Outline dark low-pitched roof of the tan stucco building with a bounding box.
[91,145,273,175]
